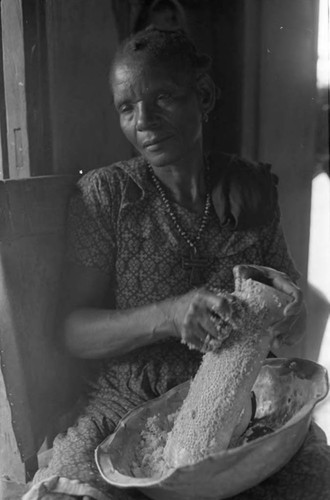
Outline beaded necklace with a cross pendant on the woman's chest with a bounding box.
[147,163,211,286]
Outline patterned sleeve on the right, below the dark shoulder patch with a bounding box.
[261,209,300,283]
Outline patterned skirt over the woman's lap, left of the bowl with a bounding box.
[31,343,200,500]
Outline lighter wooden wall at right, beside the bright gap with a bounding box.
[241,0,318,357]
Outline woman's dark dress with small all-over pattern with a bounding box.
[26,158,330,500]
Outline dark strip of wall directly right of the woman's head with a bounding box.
[183,0,244,157]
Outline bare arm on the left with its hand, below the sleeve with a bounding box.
[61,266,235,359]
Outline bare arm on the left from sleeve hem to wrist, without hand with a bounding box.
[62,265,171,358]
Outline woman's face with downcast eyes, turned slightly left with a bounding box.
[111,57,202,167]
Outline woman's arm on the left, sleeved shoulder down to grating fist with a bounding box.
[60,169,236,358]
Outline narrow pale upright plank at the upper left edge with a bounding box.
[1,0,30,179]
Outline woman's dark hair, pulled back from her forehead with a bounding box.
[110,26,211,84]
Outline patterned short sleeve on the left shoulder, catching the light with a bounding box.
[66,170,116,274]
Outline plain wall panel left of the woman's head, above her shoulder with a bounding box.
[46,0,131,174]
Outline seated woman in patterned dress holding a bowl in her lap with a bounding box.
[28,29,325,499]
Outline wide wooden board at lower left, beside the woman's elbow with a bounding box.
[0,176,75,465]
